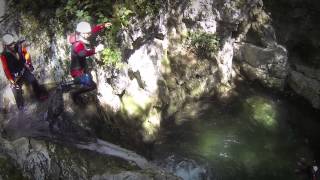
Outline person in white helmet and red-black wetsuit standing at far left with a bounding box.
[0,34,47,109]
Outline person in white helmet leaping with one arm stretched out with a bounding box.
[69,21,112,104]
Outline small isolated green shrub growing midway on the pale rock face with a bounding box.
[189,31,219,59]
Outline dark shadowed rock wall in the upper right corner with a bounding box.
[265,0,320,109]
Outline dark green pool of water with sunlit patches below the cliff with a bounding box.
[155,84,320,180]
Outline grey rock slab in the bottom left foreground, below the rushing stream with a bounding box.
[0,138,179,180]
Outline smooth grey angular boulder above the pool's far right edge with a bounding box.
[236,43,288,89]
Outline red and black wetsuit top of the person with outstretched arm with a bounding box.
[70,25,105,78]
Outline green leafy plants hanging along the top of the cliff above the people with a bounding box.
[9,0,163,68]
